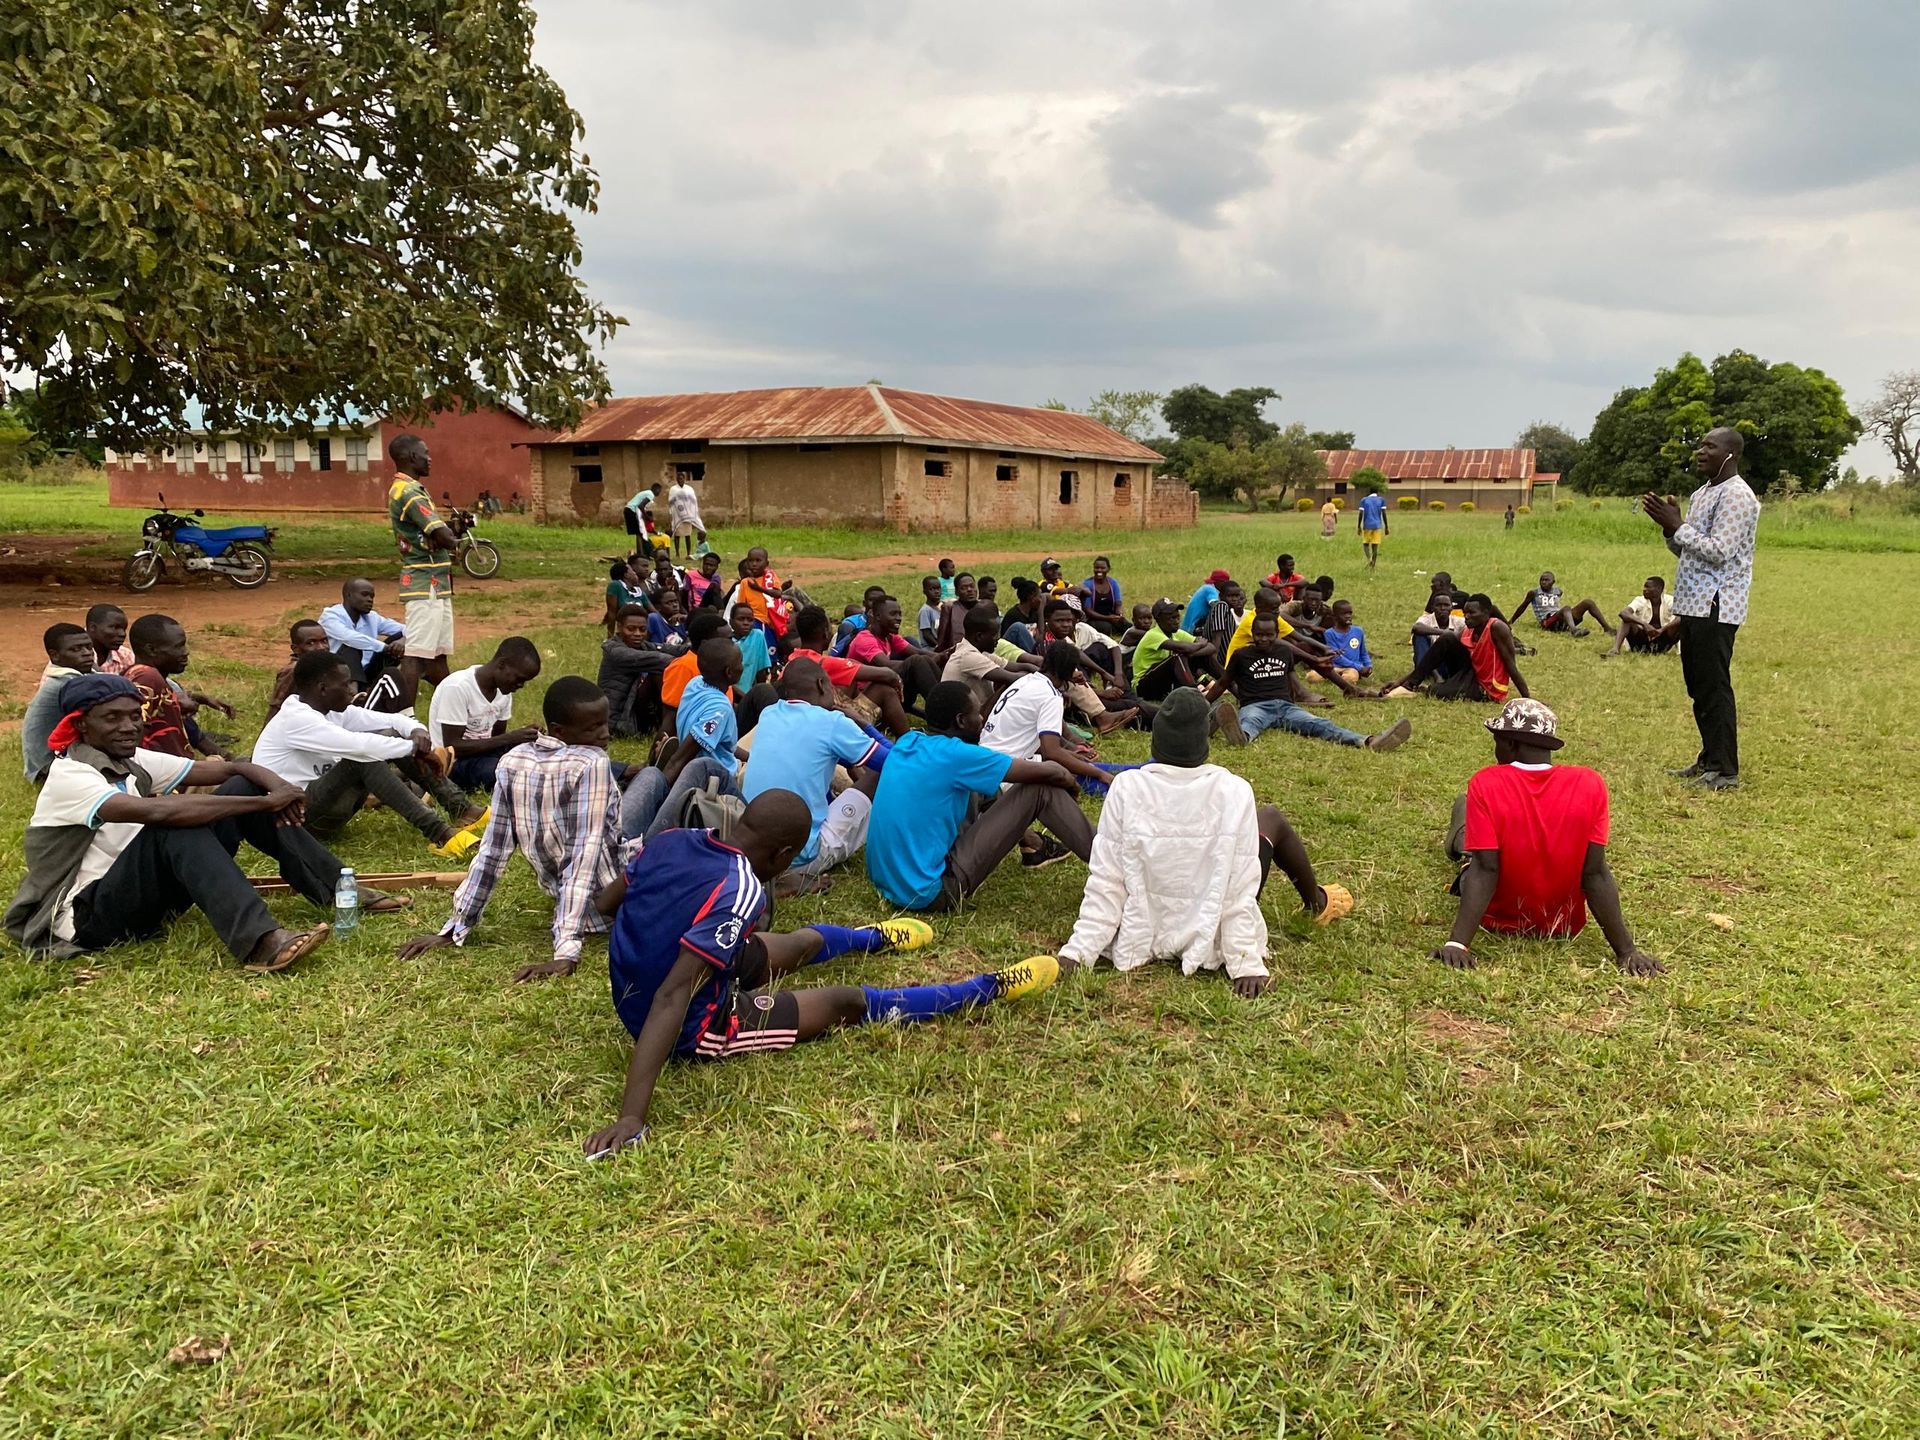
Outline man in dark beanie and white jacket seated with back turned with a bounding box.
[1060,687,1354,1000]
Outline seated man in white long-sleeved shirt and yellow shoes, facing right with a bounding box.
[253,651,484,858]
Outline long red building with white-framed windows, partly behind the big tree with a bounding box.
[108,407,553,516]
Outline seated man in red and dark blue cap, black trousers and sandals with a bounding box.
[6,674,407,972]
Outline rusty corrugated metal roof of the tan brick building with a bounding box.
[553,386,1160,461]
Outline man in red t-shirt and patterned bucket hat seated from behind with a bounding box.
[1432,699,1663,975]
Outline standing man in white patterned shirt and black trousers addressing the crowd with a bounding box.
[1640,426,1761,789]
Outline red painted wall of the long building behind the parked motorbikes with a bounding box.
[108,409,551,516]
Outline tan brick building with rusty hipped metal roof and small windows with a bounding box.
[530,386,1196,532]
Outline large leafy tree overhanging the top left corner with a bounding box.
[0,0,620,444]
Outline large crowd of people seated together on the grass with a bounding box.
[6,524,1676,1154]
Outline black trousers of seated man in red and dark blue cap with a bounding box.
[73,778,340,960]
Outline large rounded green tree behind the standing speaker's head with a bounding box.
[1571,349,1860,495]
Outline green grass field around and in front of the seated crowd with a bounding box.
[11,492,1920,1438]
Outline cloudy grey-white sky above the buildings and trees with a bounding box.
[536,0,1920,470]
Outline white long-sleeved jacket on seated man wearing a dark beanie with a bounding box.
[1060,764,1267,979]
